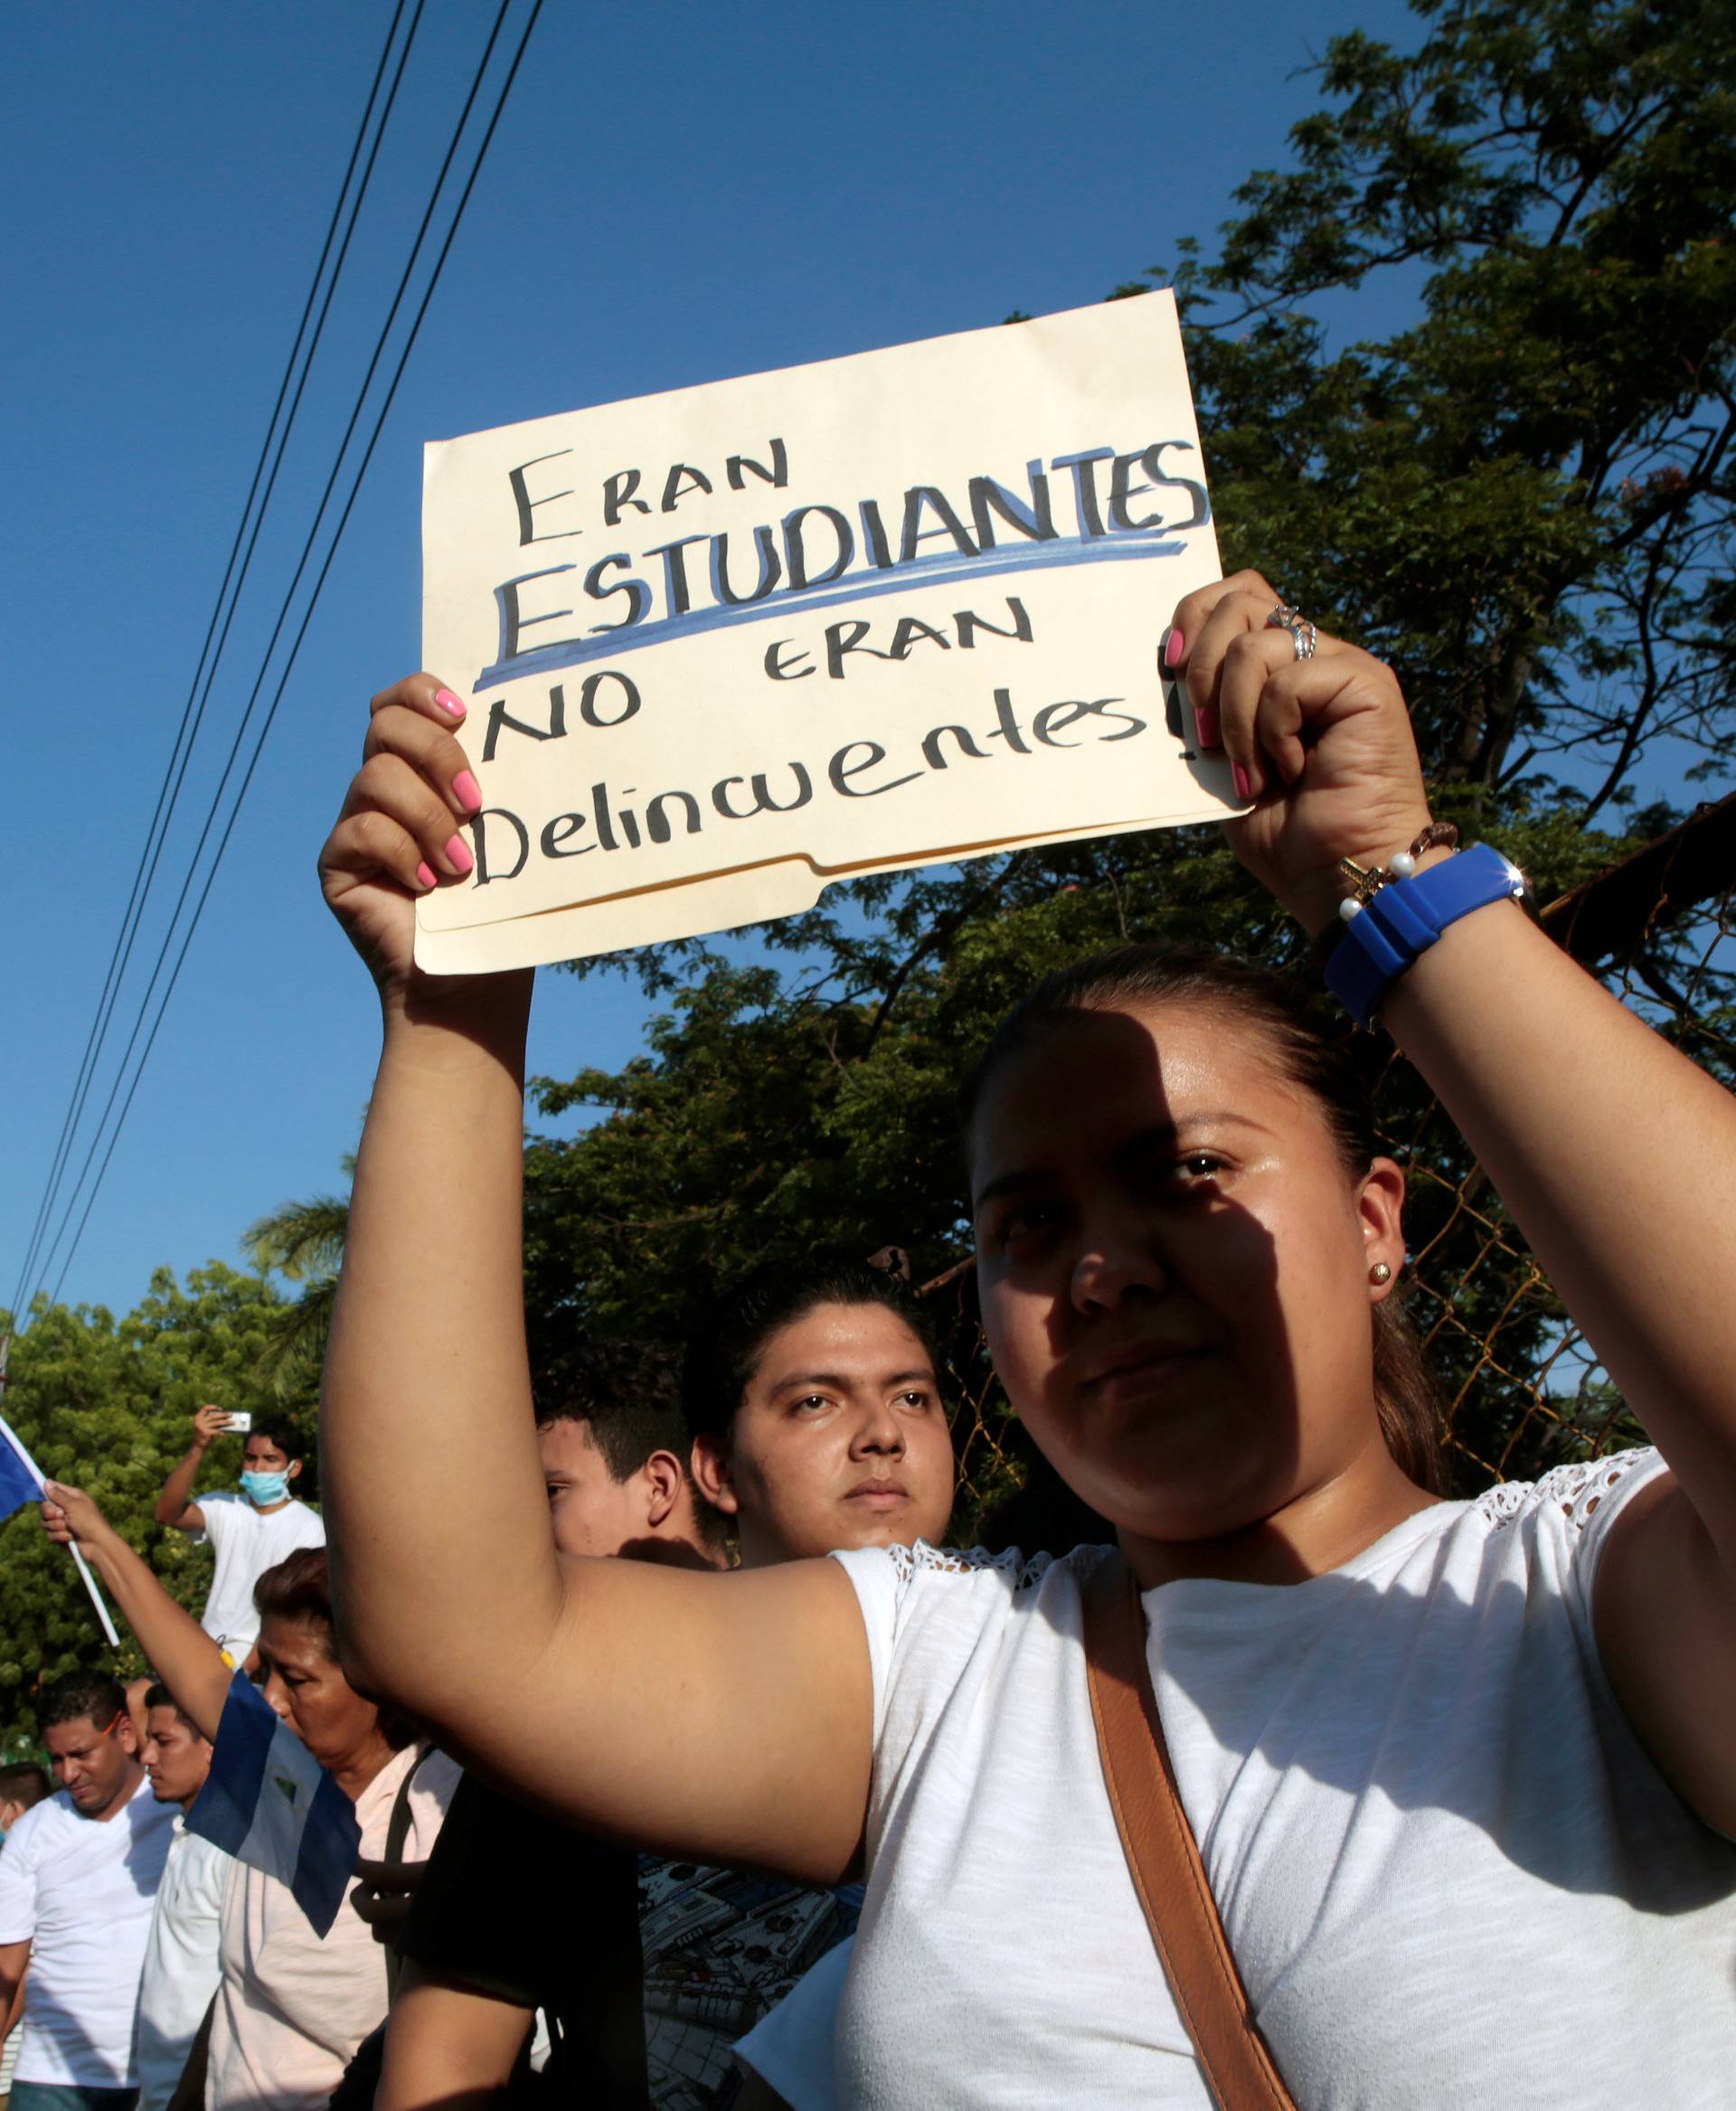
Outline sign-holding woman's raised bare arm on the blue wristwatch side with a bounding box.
[1176,574,1736,1833]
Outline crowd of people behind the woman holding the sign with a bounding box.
[0,1262,955,2111]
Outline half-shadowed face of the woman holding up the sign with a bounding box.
[971,1003,1402,1539]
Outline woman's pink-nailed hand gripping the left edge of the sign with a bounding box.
[319,674,482,998]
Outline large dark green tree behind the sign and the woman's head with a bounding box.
[250,0,1736,1531]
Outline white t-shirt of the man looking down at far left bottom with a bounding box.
[0,1779,175,2090]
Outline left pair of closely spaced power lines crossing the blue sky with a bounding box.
[13,0,422,1315]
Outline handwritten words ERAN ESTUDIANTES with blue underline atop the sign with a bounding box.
[476,439,1210,688]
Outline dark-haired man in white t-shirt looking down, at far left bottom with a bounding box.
[0,1672,174,2111]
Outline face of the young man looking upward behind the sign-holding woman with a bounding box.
[699,1305,955,1567]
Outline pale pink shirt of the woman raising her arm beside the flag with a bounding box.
[205,1746,458,2111]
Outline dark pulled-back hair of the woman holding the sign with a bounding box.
[958,944,1448,1494]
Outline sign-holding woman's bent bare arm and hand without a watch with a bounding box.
[321,675,873,1879]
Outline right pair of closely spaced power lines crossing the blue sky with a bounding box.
[42,0,542,1305]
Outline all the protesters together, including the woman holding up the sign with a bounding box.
[0,574,1736,2111]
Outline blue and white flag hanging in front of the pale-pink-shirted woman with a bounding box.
[186,1672,361,1936]
